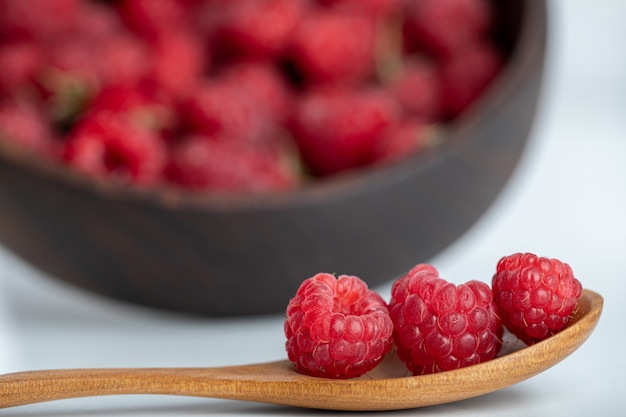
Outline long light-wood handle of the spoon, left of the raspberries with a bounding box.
[0,361,290,408]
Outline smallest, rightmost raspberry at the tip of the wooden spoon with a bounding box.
[492,253,582,344]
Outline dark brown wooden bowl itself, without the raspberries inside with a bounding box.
[0,0,547,315]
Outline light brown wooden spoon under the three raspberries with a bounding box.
[0,290,603,410]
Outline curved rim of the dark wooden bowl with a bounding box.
[0,0,547,212]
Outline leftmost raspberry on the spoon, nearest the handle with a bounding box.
[285,273,393,378]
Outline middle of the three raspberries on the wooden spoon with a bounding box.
[389,264,502,375]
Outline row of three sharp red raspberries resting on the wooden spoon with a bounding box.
[284,253,582,378]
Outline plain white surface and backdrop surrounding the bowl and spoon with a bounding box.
[0,0,626,417]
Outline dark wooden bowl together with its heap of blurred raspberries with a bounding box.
[0,0,547,315]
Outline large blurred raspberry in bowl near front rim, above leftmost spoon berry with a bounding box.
[290,89,401,175]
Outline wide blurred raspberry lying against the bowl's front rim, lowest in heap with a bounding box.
[166,136,300,193]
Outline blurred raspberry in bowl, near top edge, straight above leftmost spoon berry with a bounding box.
[290,10,376,84]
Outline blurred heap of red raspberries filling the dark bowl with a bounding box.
[0,0,503,193]
